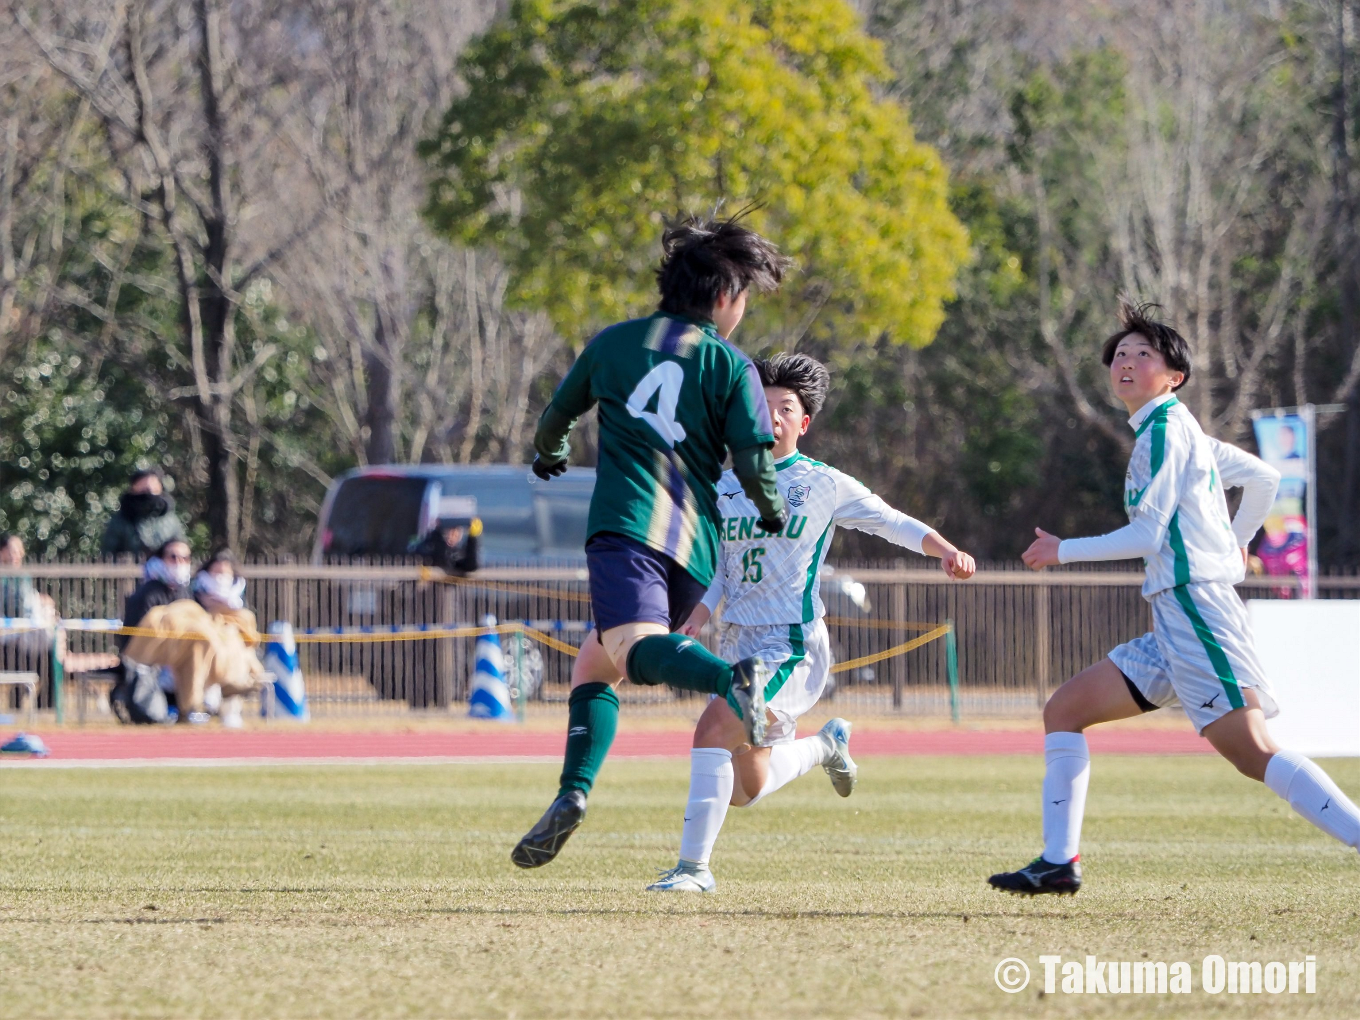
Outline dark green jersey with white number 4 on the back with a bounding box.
[534,311,774,585]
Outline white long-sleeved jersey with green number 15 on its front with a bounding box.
[703,453,932,626]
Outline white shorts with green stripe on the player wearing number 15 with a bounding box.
[721,619,831,747]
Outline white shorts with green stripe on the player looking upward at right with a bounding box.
[1110,583,1280,732]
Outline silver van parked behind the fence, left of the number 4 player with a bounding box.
[311,464,596,571]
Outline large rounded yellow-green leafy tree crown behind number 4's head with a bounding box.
[424,0,967,345]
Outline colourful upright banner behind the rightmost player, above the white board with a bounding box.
[1253,407,1318,598]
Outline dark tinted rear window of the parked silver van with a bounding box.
[325,476,430,556]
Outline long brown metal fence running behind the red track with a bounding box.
[0,563,1360,715]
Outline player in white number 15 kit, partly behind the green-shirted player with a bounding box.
[647,354,976,892]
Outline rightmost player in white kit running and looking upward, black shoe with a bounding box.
[989,302,1360,895]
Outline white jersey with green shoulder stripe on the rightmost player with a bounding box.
[1123,394,1255,597]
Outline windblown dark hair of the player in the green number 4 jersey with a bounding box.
[657,215,793,320]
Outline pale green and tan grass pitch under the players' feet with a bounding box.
[0,758,1360,1017]
